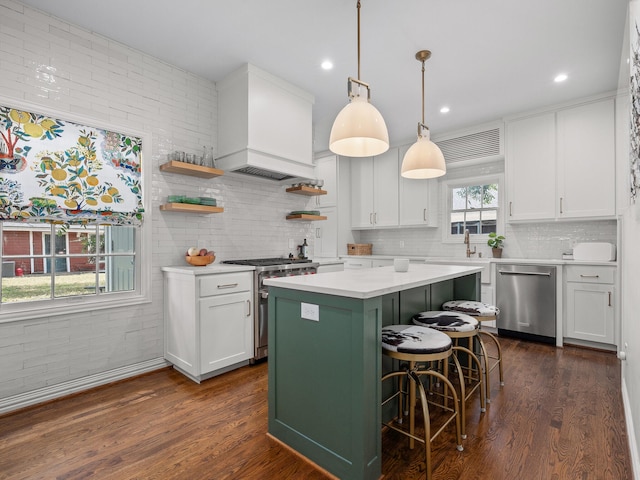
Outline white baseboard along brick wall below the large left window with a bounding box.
[0,357,168,414]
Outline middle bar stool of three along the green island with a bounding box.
[412,311,486,438]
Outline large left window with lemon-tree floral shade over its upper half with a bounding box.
[0,105,150,321]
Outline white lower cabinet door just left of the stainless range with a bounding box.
[200,292,253,375]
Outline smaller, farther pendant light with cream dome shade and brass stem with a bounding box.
[400,50,447,178]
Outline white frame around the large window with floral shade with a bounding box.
[0,96,153,323]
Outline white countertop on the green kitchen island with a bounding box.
[264,264,482,299]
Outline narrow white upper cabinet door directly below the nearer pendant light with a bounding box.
[348,157,373,228]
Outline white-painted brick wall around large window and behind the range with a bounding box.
[0,0,313,399]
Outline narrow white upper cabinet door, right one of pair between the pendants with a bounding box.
[373,148,399,227]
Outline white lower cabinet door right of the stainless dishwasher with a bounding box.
[566,282,615,344]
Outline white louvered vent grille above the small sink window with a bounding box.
[434,127,502,163]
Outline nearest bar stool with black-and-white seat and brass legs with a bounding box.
[382,325,463,480]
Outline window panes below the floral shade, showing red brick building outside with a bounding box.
[0,222,139,304]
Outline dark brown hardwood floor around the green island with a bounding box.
[0,338,632,480]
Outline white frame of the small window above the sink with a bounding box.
[442,173,505,244]
